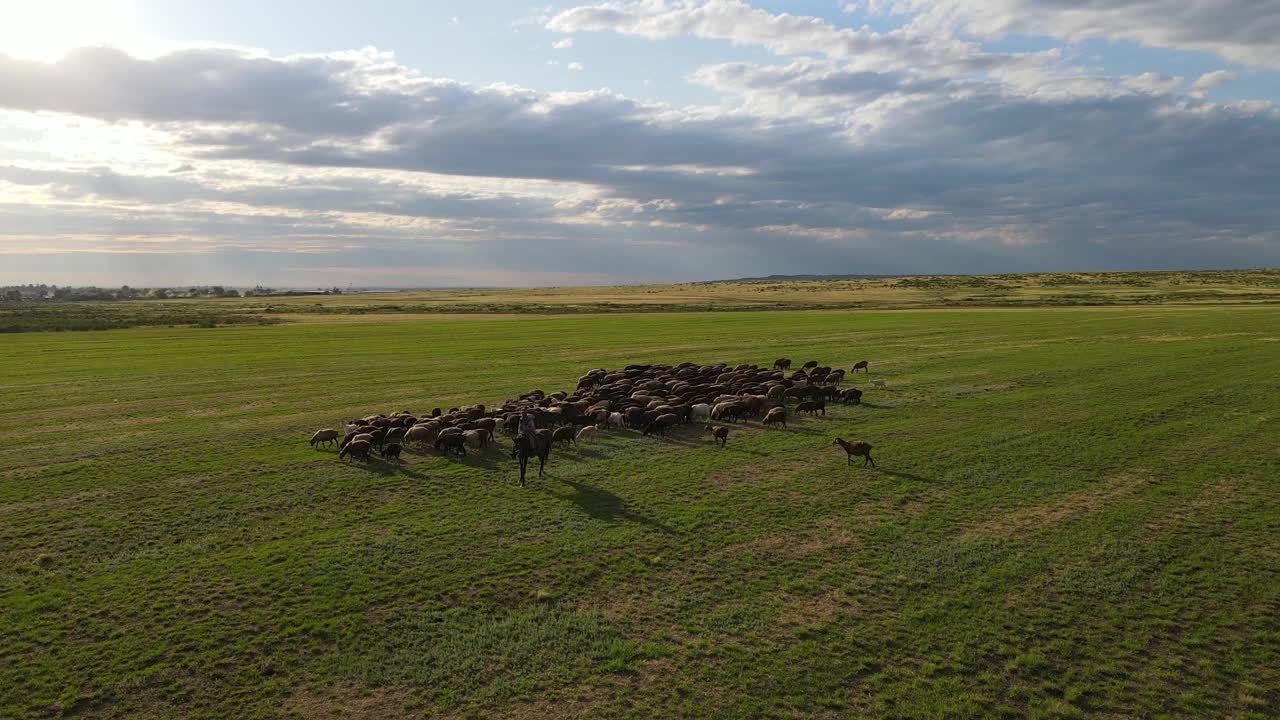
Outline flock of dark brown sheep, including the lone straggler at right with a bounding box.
[304,357,876,475]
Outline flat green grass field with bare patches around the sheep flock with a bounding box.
[0,305,1280,720]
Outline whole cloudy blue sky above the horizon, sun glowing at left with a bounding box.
[0,0,1280,287]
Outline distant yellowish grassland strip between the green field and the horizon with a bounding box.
[0,269,1280,333]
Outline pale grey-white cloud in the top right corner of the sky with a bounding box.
[891,0,1280,69]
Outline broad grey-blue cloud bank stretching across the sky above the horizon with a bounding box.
[0,25,1280,284]
